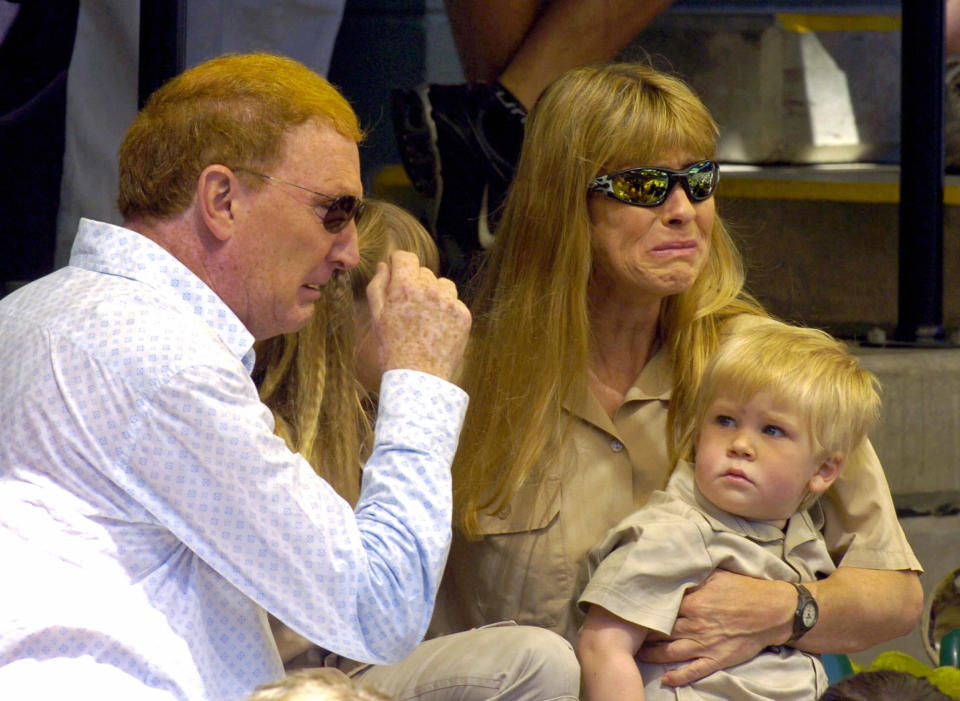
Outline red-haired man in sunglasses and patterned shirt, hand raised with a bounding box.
[0,54,470,700]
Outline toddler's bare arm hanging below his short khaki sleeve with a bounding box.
[577,604,647,701]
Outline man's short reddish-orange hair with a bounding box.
[117,53,363,219]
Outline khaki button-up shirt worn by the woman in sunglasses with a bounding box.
[428,330,922,643]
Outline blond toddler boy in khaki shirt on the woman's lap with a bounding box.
[578,320,880,701]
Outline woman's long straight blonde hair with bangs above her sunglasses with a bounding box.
[453,64,763,537]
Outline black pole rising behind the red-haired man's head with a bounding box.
[137,0,186,109]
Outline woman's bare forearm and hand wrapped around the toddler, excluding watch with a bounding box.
[638,567,923,686]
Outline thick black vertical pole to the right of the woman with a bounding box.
[895,0,944,342]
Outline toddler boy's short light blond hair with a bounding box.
[694,319,880,459]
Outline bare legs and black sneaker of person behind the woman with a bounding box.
[393,0,673,283]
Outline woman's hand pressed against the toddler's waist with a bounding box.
[637,570,797,686]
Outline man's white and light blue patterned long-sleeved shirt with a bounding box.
[0,220,466,701]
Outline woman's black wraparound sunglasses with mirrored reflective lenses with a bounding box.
[587,161,720,207]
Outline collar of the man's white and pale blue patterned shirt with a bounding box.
[70,219,255,372]
